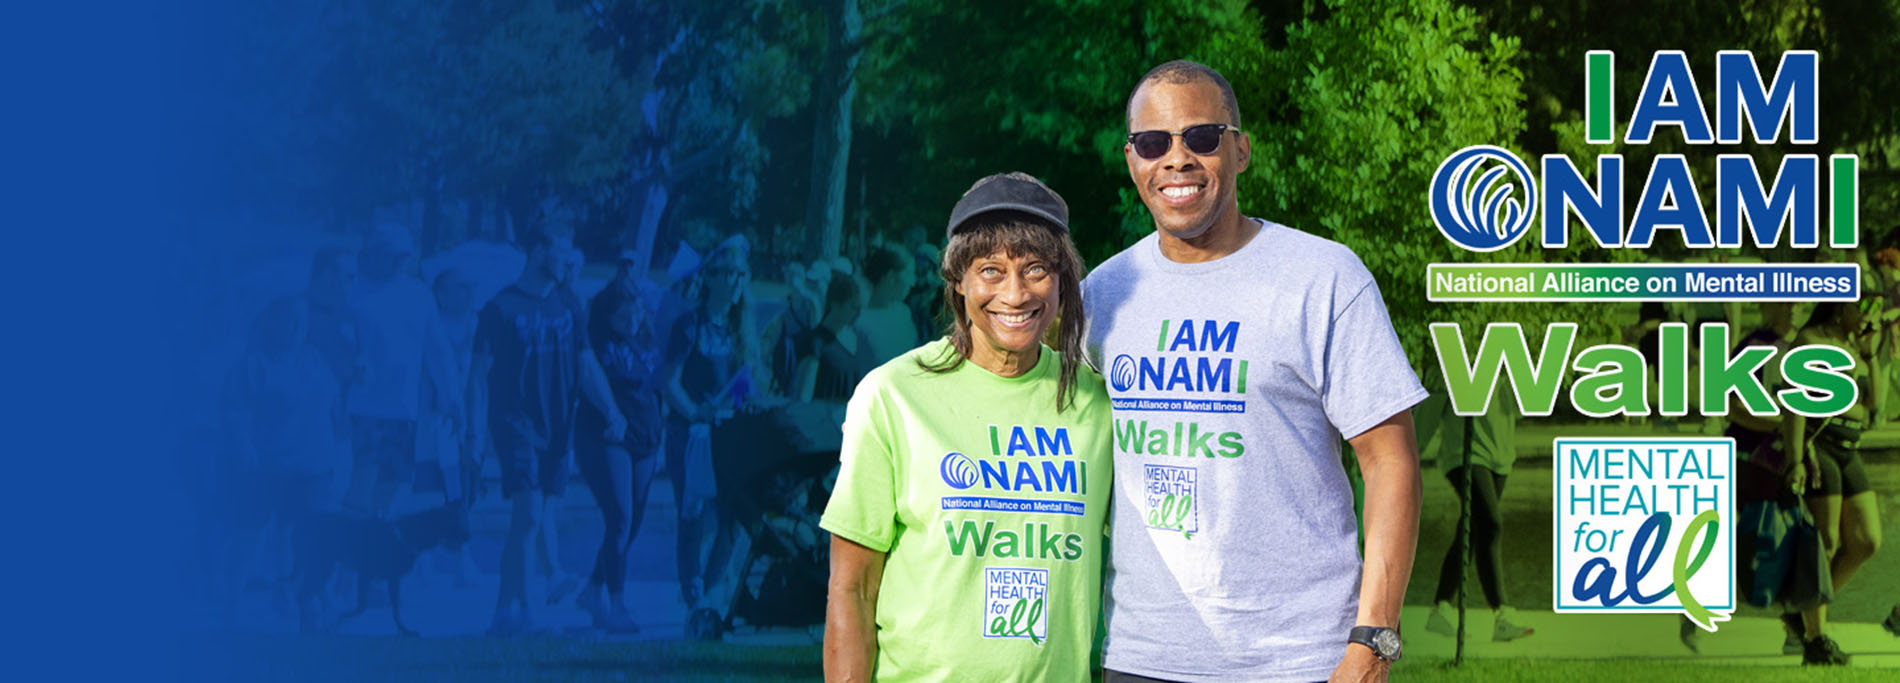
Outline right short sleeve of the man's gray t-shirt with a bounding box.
[1324,278,1427,439]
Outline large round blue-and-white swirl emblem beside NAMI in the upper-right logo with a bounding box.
[1431,145,1537,251]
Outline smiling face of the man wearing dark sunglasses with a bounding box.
[1123,80,1252,240]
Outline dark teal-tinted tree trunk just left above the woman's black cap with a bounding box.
[806,0,865,259]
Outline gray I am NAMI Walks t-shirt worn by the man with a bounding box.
[1083,221,1425,681]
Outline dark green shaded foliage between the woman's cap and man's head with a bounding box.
[861,0,1265,263]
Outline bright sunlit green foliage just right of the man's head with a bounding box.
[1231,0,1596,358]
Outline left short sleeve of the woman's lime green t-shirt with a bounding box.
[819,379,897,552]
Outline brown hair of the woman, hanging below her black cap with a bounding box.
[918,211,1083,413]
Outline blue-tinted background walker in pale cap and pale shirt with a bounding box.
[346,223,448,516]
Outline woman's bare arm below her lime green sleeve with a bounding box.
[825,535,884,683]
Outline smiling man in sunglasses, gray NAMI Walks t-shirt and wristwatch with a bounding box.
[1083,63,1425,681]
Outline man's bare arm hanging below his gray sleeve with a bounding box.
[1332,409,1425,681]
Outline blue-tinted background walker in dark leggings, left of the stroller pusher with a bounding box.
[574,259,661,634]
